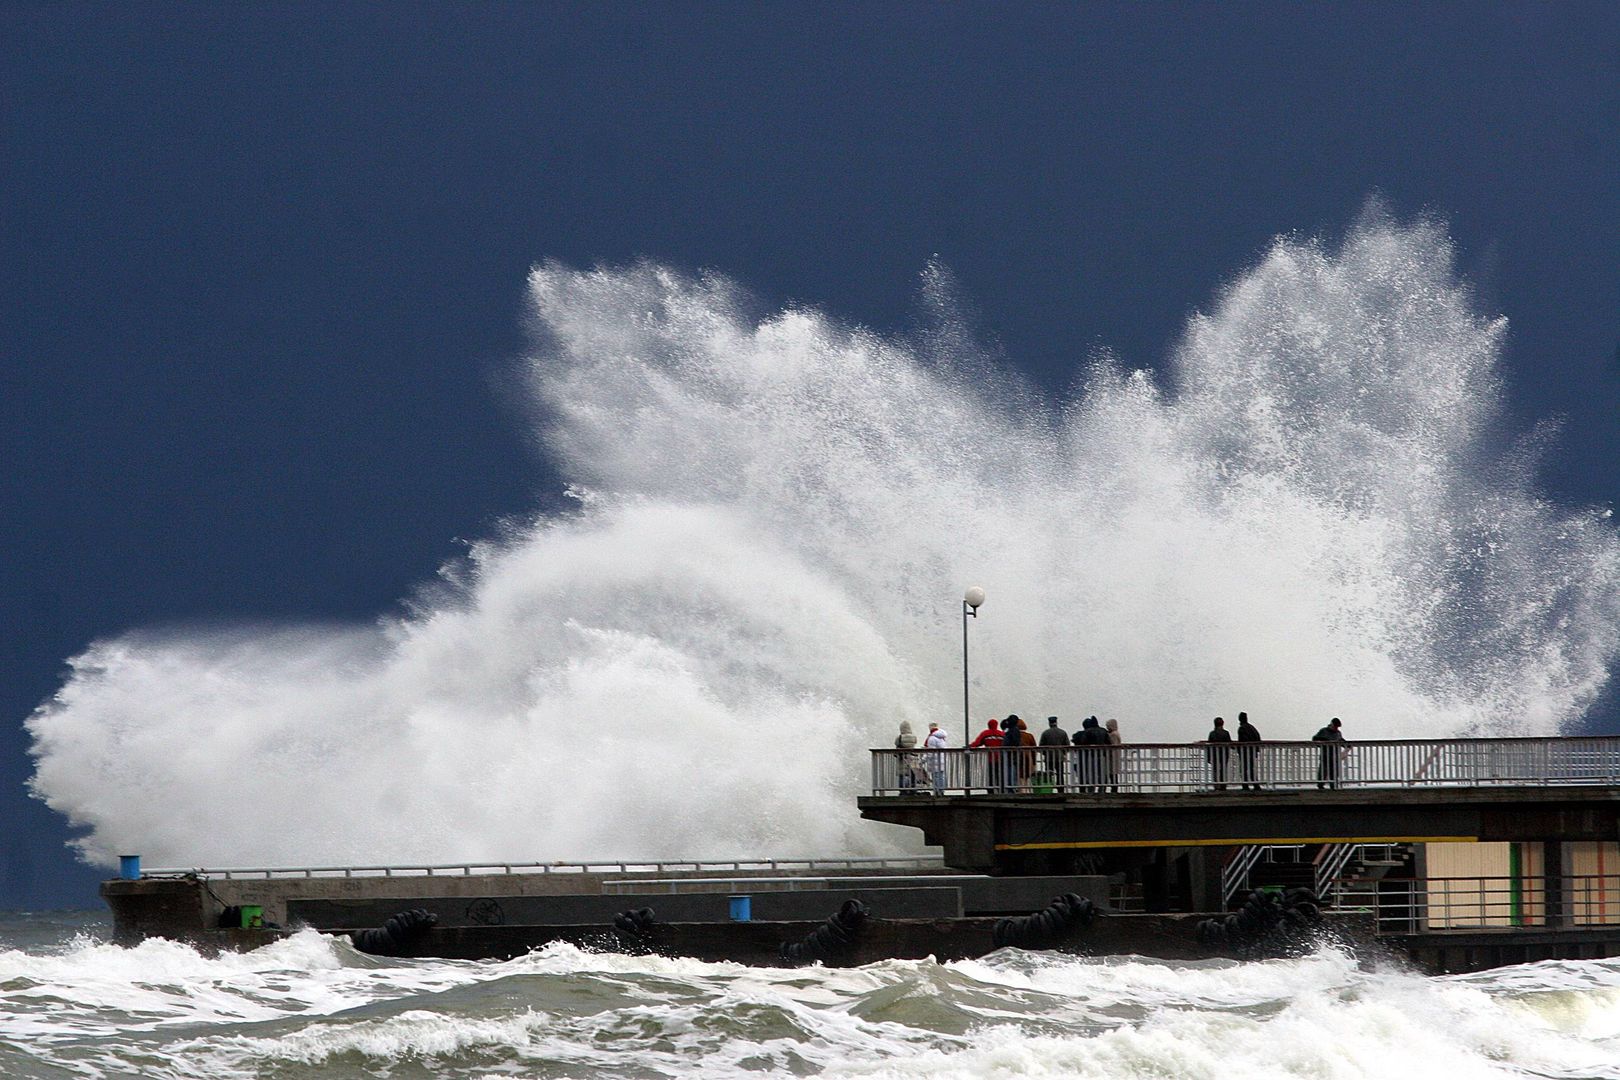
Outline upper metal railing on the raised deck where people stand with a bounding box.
[872,737,1620,795]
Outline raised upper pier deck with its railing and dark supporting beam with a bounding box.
[857,737,1620,910]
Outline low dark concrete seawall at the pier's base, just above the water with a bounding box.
[102,871,1620,972]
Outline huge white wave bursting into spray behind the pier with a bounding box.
[28,212,1620,865]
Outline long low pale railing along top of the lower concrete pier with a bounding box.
[141,855,944,881]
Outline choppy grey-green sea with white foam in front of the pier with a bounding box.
[0,913,1620,1080]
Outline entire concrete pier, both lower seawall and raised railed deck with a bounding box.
[102,738,1620,970]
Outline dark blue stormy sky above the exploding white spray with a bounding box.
[9,2,1620,908]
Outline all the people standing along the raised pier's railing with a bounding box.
[894,712,1345,793]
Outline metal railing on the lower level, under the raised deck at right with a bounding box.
[1335,874,1620,934]
